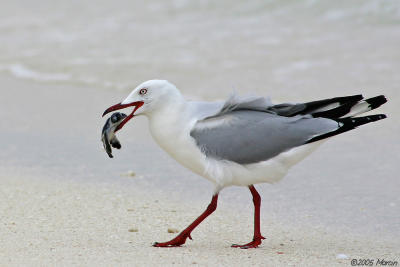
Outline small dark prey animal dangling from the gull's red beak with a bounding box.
[101,112,126,158]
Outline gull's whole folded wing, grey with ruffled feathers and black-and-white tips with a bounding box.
[190,95,386,164]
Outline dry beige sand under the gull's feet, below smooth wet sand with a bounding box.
[0,168,400,266]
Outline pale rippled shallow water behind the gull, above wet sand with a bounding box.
[0,0,400,100]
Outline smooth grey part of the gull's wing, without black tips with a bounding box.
[190,110,339,164]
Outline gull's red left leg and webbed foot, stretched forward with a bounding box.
[153,193,218,247]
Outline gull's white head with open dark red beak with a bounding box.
[103,80,181,131]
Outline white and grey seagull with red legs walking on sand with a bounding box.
[103,80,387,249]
